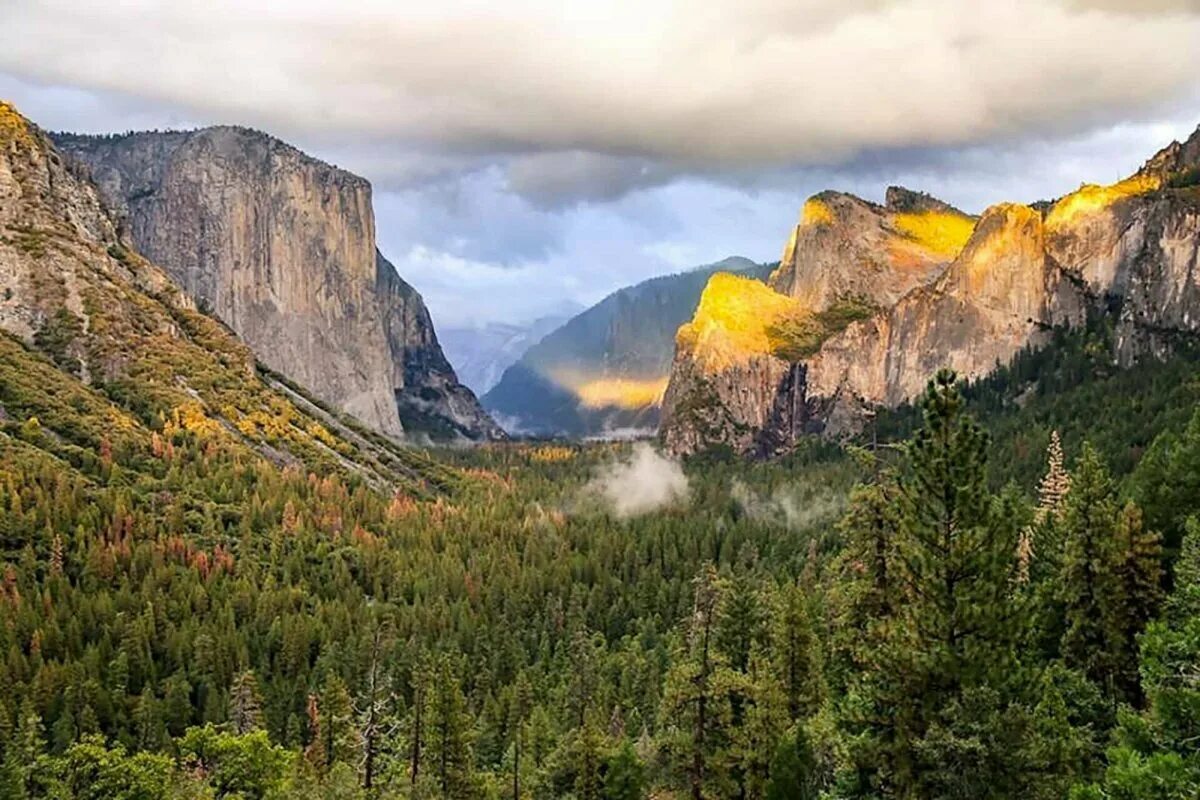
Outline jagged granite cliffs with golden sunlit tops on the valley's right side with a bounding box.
[660,130,1200,456]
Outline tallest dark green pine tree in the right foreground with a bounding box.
[844,371,1024,799]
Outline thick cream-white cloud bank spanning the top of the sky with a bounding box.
[0,0,1200,172]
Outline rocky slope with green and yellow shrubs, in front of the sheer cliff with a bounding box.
[0,102,457,494]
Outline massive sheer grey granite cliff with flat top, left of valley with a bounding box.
[56,127,503,439]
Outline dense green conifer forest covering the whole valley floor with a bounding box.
[0,319,1200,800]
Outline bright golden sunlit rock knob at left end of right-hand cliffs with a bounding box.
[676,272,804,372]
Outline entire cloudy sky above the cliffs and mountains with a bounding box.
[0,0,1200,326]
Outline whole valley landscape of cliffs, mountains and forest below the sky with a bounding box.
[0,76,1200,800]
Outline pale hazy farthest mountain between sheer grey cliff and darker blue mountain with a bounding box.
[438,302,583,396]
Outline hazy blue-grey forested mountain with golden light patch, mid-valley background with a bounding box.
[484,257,770,437]
